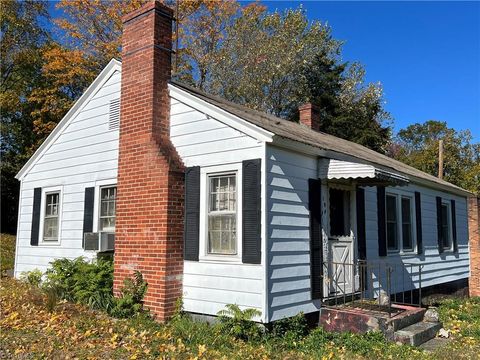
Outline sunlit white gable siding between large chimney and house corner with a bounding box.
[170,98,265,320]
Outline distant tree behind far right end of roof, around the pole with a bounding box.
[389,120,480,194]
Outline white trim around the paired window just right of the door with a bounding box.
[385,189,417,256]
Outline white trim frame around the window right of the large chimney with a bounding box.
[198,163,243,264]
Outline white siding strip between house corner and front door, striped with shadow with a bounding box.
[267,145,318,321]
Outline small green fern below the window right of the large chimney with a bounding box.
[217,304,261,340]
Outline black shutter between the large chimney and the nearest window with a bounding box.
[183,166,200,261]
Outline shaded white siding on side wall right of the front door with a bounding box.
[365,184,469,290]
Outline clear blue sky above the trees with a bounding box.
[50,1,480,142]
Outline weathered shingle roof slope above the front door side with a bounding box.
[172,81,467,192]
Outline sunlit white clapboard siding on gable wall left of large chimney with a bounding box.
[15,71,120,276]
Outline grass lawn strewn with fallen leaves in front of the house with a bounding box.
[0,278,480,360]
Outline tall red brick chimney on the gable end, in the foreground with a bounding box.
[114,1,184,321]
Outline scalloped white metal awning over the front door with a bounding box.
[318,158,410,186]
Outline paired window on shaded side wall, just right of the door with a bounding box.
[386,194,414,251]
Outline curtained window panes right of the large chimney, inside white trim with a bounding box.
[207,174,237,255]
